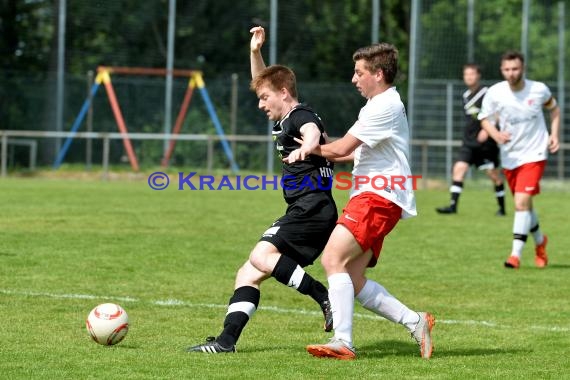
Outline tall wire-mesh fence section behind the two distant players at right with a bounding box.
[408,0,570,180]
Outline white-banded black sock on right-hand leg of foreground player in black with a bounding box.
[271,255,329,304]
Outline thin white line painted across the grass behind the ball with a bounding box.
[0,289,570,332]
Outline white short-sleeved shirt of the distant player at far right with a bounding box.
[479,79,552,169]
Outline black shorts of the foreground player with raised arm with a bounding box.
[259,193,338,267]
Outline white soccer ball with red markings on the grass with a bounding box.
[85,303,129,346]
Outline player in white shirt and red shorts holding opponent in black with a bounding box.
[282,43,435,360]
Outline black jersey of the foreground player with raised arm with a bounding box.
[273,104,334,203]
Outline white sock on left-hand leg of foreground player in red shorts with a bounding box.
[328,273,354,347]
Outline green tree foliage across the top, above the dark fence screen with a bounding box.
[0,0,570,81]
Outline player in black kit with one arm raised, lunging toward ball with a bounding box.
[187,27,338,353]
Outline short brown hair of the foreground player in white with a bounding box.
[352,43,398,84]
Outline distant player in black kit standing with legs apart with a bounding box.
[436,63,505,216]
